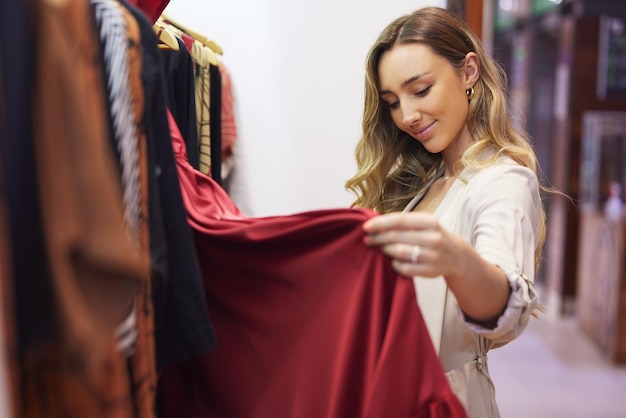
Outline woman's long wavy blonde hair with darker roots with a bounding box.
[346,7,545,272]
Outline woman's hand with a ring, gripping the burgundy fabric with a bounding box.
[363,212,467,277]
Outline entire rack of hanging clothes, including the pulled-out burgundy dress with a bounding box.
[0,0,466,418]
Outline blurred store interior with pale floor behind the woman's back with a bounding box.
[466,0,626,418]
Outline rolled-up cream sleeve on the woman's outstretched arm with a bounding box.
[458,165,543,345]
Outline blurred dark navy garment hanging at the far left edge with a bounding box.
[0,1,57,366]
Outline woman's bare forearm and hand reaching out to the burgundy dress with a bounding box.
[364,212,511,327]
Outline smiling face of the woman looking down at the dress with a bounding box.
[378,44,477,153]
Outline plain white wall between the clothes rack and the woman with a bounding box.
[164,0,446,216]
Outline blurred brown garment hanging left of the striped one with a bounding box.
[14,1,149,418]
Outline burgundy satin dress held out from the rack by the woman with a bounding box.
[158,112,465,418]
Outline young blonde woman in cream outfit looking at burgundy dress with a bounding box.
[346,8,545,418]
